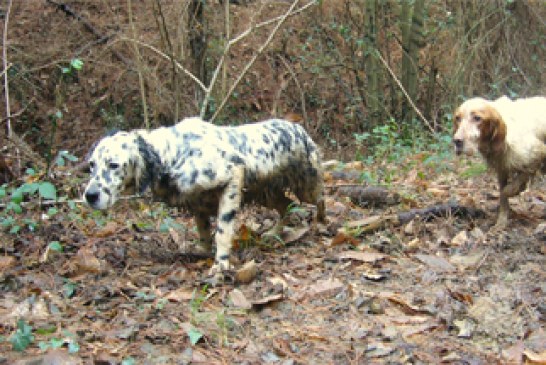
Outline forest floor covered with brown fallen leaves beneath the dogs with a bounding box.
[0,155,546,364]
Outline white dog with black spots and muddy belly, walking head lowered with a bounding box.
[83,118,324,279]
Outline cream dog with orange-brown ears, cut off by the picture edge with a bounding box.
[453,96,546,228]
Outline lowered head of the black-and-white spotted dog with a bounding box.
[83,132,143,209]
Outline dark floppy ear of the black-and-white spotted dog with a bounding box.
[135,136,161,194]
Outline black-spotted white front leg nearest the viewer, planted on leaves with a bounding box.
[209,166,244,280]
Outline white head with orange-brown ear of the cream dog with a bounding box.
[453,98,506,155]
